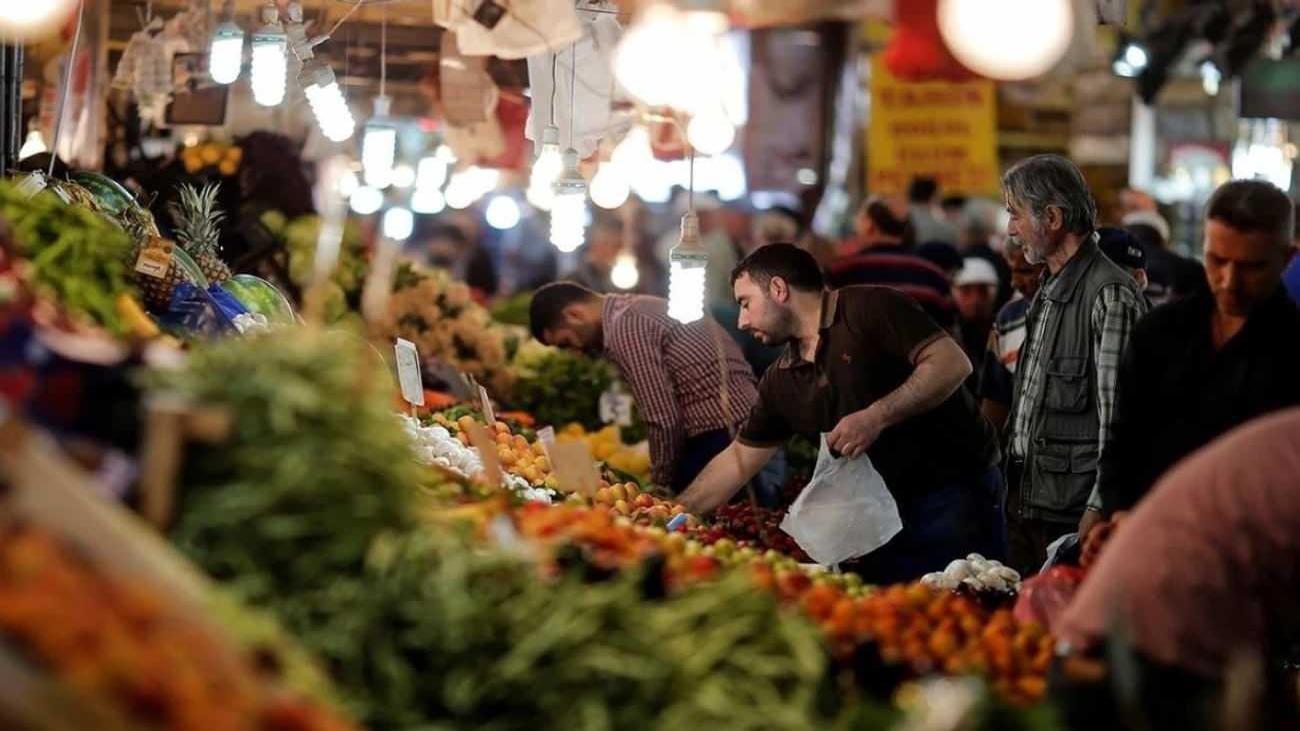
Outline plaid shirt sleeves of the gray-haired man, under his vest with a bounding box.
[1010,249,1147,510]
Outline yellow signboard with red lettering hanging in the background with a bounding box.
[866,55,998,196]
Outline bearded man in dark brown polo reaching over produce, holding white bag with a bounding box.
[680,245,1005,581]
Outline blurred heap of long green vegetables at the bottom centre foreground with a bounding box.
[342,535,847,731]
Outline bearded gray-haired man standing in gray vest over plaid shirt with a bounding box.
[1002,155,1147,574]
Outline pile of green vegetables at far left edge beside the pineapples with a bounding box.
[0,181,134,334]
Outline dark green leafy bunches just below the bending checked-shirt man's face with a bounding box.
[511,341,614,431]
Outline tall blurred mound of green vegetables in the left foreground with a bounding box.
[146,328,425,639]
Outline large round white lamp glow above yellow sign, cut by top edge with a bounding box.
[939,0,1074,81]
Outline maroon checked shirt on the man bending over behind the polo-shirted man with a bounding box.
[601,294,758,485]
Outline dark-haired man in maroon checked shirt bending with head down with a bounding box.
[529,282,758,492]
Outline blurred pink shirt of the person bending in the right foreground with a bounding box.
[1060,408,1300,676]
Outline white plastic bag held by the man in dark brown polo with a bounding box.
[781,434,902,566]
